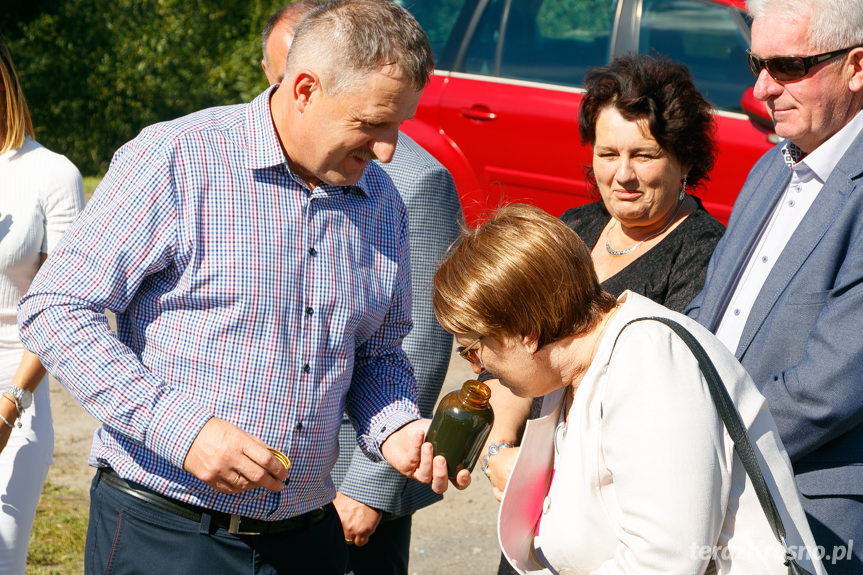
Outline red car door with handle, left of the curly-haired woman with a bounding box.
[437,0,616,220]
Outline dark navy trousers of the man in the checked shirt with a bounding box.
[84,473,346,575]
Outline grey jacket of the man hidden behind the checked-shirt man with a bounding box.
[333,132,462,520]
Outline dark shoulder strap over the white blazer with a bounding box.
[621,316,812,575]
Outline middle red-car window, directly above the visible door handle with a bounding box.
[463,0,617,86]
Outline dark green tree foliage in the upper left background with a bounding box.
[5,0,281,174]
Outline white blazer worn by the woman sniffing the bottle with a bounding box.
[498,292,825,575]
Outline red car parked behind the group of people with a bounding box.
[397,0,776,222]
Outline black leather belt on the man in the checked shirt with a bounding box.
[98,467,335,535]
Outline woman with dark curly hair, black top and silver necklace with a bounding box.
[486,54,725,574]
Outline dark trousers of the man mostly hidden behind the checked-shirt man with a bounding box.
[345,515,413,575]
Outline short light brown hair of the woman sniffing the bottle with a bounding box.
[433,204,616,349]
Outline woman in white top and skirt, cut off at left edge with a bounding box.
[0,41,84,575]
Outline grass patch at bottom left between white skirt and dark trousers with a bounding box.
[27,482,89,575]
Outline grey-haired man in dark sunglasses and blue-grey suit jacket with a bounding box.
[688,0,863,574]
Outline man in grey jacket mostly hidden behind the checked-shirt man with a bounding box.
[261,0,461,575]
